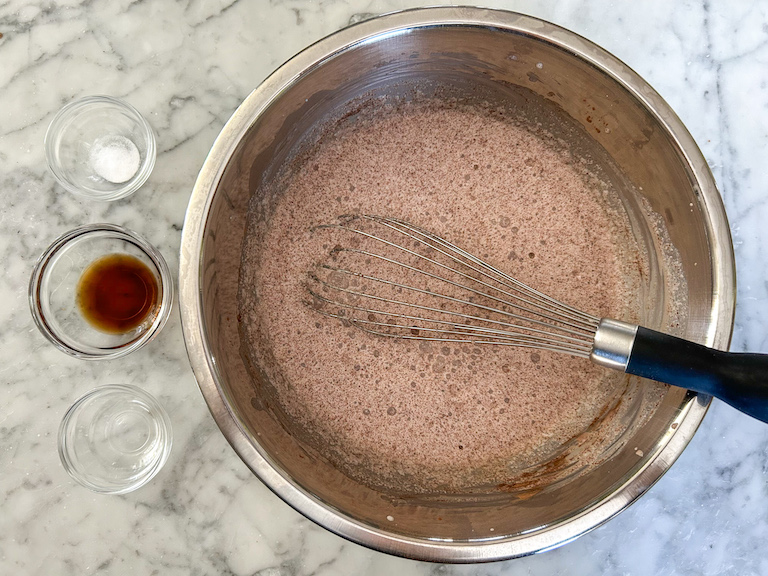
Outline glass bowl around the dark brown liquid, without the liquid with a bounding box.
[29,224,173,360]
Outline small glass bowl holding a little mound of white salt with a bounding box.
[45,96,157,201]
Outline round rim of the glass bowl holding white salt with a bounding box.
[43,94,157,202]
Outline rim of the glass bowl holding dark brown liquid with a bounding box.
[28,223,175,360]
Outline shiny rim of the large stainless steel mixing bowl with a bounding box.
[179,7,736,563]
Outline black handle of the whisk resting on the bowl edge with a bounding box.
[626,326,768,422]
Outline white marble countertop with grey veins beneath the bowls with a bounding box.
[0,0,768,576]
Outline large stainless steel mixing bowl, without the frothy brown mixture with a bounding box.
[179,8,735,562]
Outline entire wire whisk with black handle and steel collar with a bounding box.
[307,215,768,422]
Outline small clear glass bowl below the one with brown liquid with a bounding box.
[59,384,173,494]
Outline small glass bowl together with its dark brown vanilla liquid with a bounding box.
[29,224,173,360]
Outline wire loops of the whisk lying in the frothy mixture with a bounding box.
[307,215,600,357]
